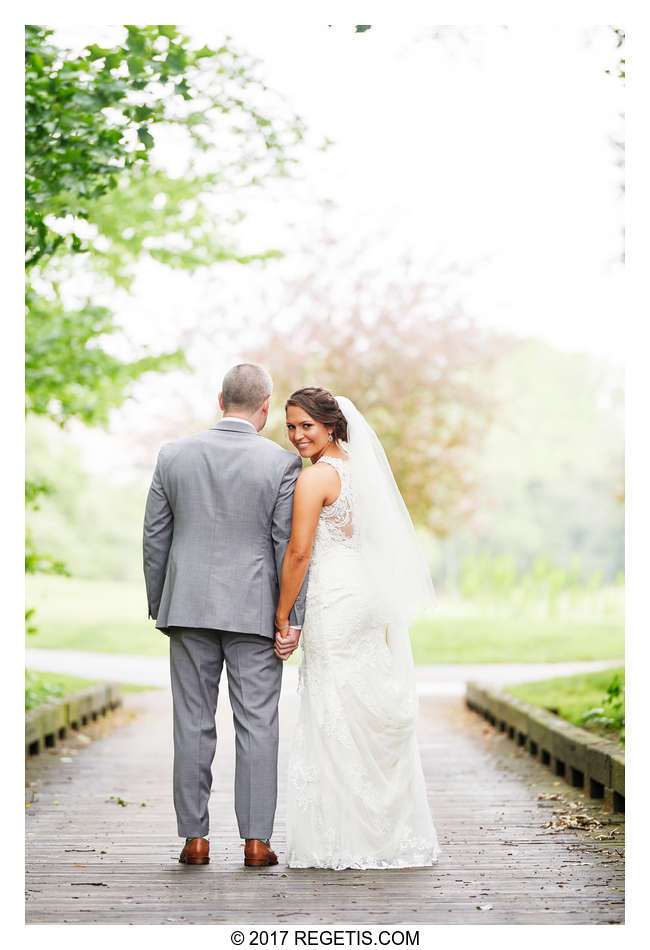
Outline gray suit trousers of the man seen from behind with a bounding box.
[169,627,282,840]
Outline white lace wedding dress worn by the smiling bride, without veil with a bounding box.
[287,457,440,869]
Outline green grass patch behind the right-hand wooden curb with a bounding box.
[503,666,625,737]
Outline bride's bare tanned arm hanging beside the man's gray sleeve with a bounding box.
[275,465,338,628]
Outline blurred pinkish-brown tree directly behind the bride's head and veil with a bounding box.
[246,255,514,537]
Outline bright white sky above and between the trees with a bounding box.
[46,19,623,476]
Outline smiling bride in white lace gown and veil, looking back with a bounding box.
[276,387,440,869]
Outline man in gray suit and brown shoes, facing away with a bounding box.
[143,363,306,867]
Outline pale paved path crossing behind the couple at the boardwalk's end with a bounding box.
[25,650,625,696]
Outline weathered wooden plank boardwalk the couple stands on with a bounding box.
[26,683,624,928]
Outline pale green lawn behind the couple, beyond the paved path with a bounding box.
[27,575,625,664]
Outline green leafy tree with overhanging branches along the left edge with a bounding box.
[25,25,304,616]
